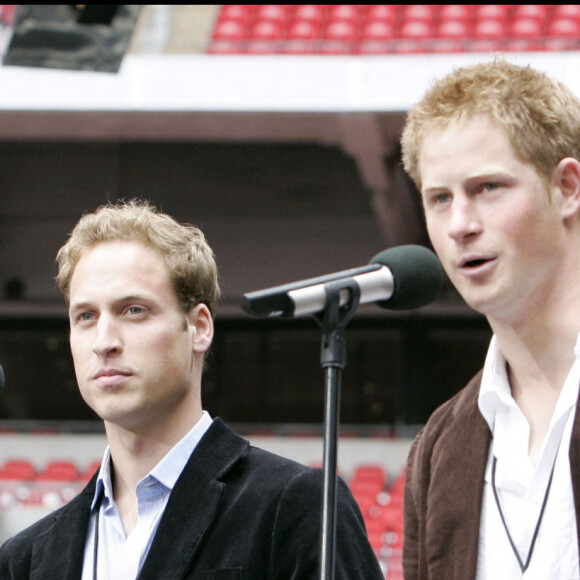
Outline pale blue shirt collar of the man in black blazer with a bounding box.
[91,411,212,511]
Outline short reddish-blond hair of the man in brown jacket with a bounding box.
[401,57,580,189]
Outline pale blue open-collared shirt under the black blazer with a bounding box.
[82,411,212,580]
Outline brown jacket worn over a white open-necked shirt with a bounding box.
[403,372,580,580]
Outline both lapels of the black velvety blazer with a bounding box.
[30,419,249,580]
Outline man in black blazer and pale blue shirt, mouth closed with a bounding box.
[0,201,383,580]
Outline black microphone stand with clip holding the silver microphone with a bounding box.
[315,278,360,580]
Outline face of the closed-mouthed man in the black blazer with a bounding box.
[69,241,213,430]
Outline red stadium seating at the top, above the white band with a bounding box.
[207,4,580,54]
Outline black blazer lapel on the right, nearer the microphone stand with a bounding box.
[139,419,249,580]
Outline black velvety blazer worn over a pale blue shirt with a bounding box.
[0,419,384,580]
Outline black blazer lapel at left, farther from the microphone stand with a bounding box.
[30,476,96,580]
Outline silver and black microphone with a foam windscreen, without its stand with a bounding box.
[240,245,445,318]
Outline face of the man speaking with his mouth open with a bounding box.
[419,115,565,323]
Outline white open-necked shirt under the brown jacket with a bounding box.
[477,337,580,580]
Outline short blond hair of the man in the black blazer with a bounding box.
[56,199,220,316]
